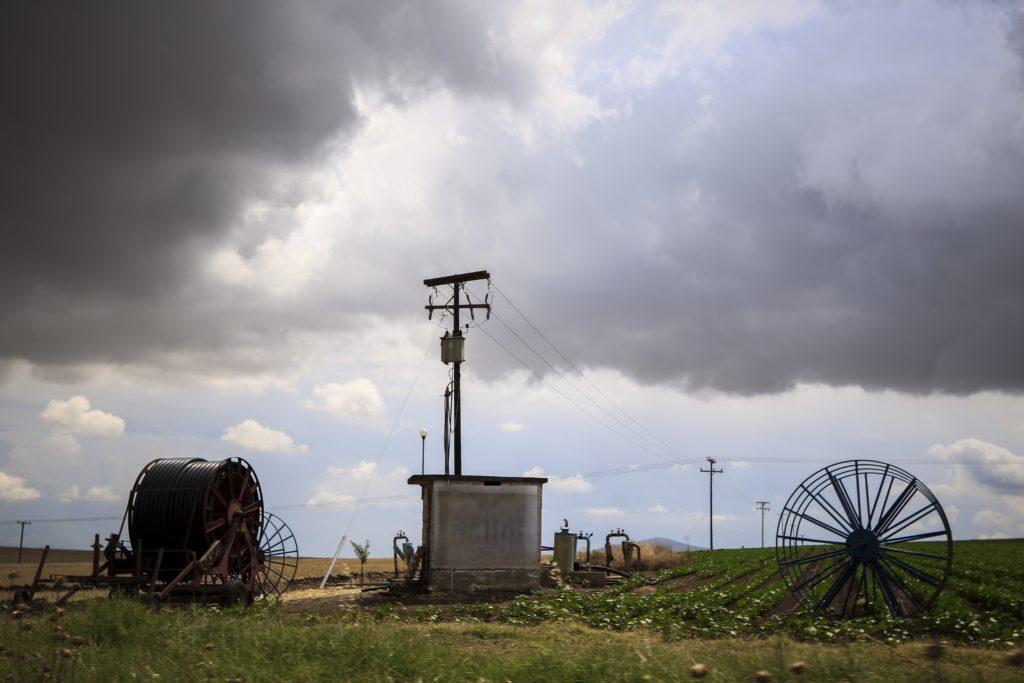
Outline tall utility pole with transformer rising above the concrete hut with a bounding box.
[423,270,490,476]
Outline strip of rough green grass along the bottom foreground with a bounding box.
[0,600,1024,683]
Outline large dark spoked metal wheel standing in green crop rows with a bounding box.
[775,460,952,616]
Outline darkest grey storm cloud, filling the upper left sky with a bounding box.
[0,1,528,374]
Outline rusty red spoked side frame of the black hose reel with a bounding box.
[193,458,263,599]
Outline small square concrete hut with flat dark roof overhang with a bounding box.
[409,475,547,593]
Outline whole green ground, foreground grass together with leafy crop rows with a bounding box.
[0,541,1024,681]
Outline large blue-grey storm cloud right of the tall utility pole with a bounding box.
[462,3,1024,394]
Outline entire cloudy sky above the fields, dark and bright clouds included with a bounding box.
[0,0,1024,554]
